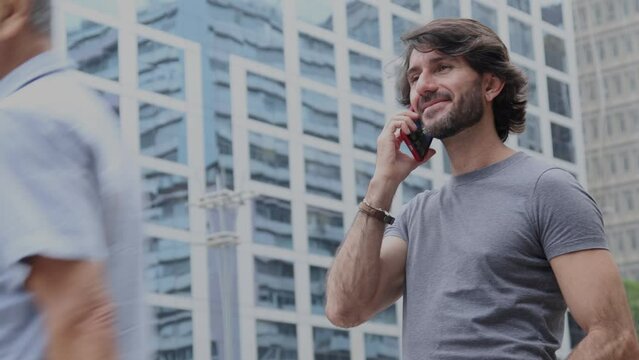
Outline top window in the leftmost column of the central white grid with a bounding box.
[246,72,287,128]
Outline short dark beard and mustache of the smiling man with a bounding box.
[422,79,484,140]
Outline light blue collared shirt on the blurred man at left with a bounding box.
[0,52,145,360]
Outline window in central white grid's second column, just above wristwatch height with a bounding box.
[304,146,342,199]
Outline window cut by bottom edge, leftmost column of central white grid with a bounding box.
[255,320,297,360]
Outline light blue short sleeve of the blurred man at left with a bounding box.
[0,111,107,269]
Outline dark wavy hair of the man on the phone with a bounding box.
[397,19,528,142]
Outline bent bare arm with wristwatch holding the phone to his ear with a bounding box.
[326,111,435,327]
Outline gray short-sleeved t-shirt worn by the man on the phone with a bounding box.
[385,153,607,360]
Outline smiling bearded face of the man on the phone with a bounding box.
[406,50,485,139]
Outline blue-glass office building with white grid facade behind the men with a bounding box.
[55,0,585,360]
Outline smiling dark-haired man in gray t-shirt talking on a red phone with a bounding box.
[326,19,639,360]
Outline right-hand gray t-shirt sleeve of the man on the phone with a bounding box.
[529,168,608,260]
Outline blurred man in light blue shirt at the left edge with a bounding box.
[0,0,145,360]
